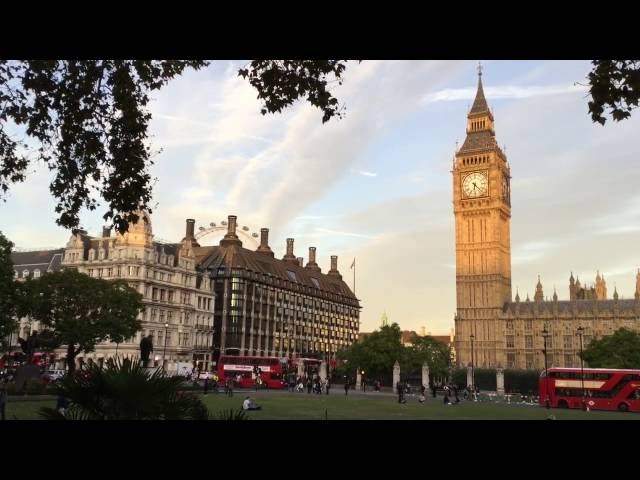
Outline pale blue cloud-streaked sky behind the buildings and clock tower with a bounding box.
[0,61,640,333]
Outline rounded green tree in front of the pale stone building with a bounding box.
[21,270,144,372]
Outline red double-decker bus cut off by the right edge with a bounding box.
[540,368,640,412]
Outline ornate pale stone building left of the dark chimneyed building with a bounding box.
[62,213,215,370]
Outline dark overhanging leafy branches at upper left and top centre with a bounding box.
[0,60,345,233]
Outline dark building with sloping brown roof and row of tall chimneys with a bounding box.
[195,216,360,358]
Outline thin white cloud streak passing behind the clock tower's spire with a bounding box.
[421,84,588,103]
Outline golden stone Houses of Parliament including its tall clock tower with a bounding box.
[452,66,640,369]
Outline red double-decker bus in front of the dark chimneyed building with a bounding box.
[218,355,286,388]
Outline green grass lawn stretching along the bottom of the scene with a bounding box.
[6,391,640,420]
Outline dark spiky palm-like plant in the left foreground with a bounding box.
[40,359,209,420]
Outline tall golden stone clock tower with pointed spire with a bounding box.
[452,67,511,367]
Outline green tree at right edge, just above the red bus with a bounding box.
[582,328,640,369]
